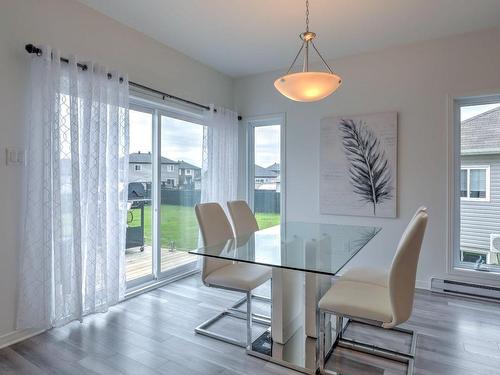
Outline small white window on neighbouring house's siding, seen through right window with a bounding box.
[460,166,490,201]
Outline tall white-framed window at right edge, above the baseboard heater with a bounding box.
[450,95,500,272]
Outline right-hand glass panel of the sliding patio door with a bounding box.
[160,113,203,274]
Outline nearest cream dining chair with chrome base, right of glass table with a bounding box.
[318,207,428,375]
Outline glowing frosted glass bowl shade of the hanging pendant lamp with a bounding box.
[274,72,342,102]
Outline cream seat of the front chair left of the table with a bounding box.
[204,263,271,292]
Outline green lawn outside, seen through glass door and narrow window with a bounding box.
[128,205,280,250]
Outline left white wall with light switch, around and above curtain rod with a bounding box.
[0,0,232,341]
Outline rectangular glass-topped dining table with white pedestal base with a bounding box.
[190,221,381,374]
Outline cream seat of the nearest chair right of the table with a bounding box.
[319,280,392,323]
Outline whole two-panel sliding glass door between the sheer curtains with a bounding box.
[125,102,203,289]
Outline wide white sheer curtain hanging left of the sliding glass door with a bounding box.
[17,47,128,329]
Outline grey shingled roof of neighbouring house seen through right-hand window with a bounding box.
[460,106,500,155]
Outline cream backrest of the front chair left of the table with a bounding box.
[195,203,233,282]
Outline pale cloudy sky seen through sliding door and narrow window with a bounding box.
[129,110,280,168]
